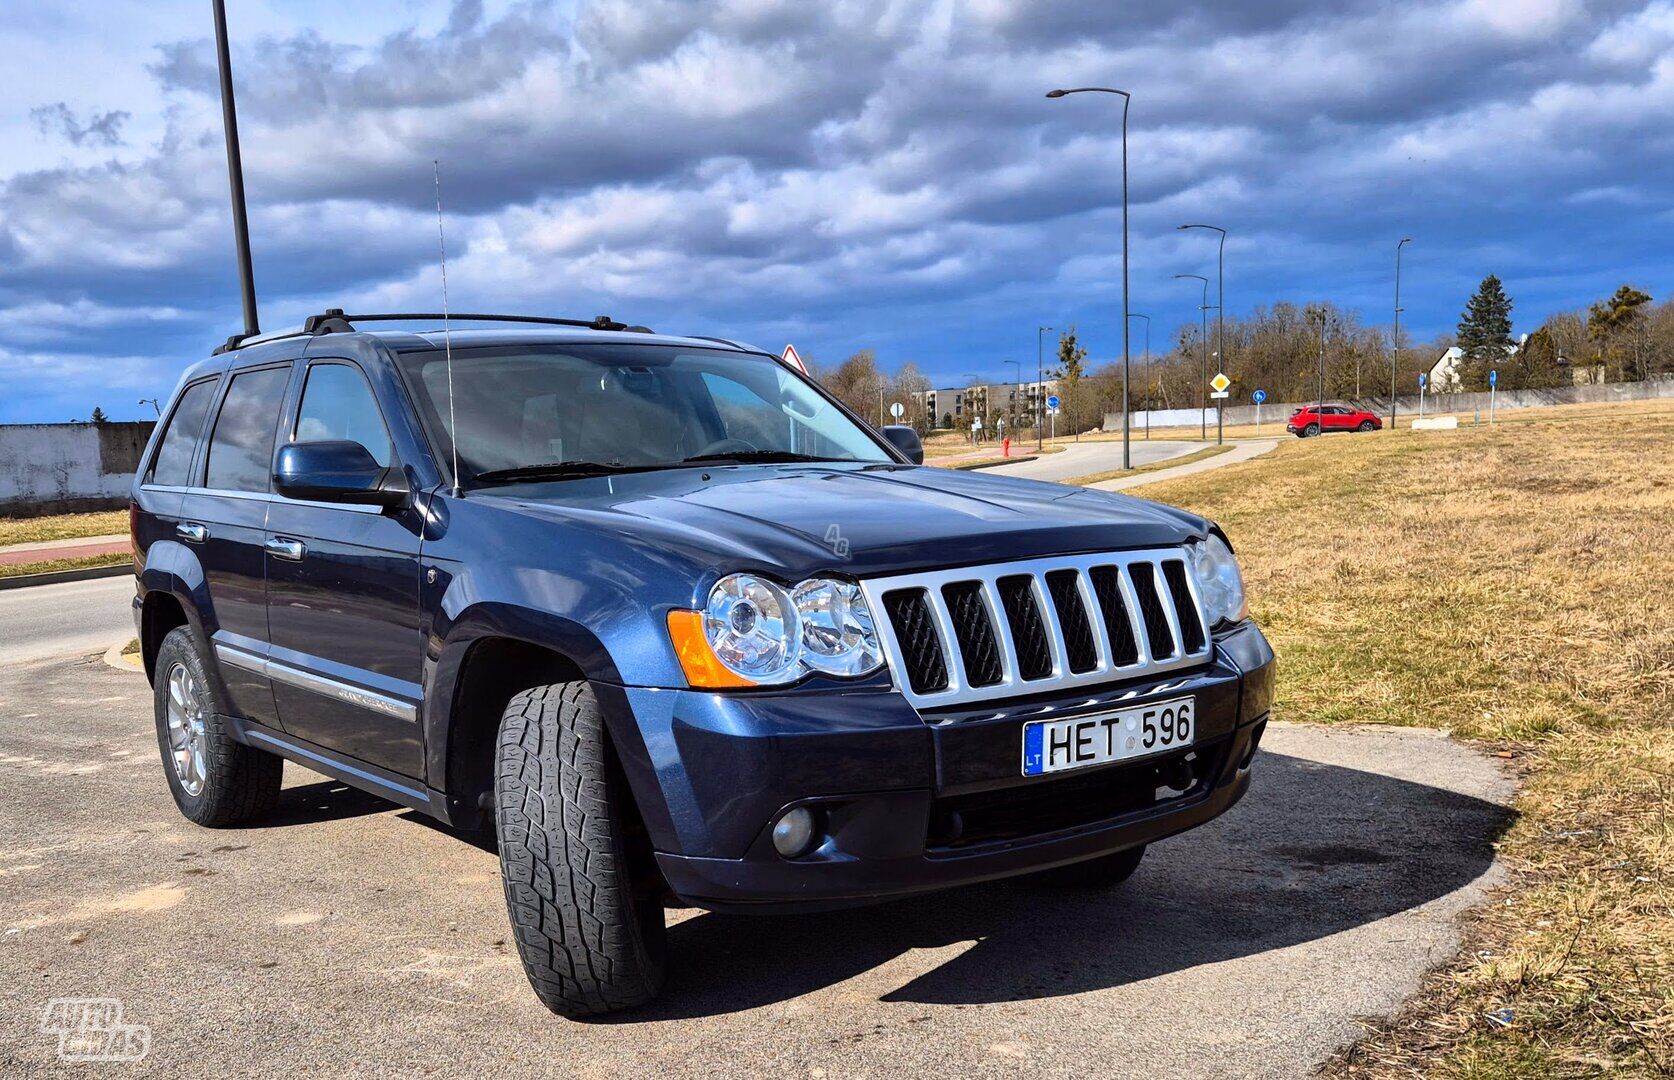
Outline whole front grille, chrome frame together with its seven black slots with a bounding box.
[860,548,1210,708]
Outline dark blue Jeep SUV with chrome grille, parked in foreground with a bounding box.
[132,310,1272,1016]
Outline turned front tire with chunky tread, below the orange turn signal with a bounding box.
[494,681,668,1018]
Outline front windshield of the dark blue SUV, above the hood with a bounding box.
[398,343,892,479]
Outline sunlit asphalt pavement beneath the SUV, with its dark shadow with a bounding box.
[0,642,1510,1080]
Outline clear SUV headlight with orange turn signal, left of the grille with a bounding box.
[668,574,884,688]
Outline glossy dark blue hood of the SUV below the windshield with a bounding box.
[472,464,1207,581]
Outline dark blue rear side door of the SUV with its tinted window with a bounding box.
[177,362,293,725]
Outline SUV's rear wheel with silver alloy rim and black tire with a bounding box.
[152,626,285,829]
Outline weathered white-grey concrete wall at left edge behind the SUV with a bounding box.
[0,420,154,517]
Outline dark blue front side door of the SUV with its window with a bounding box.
[266,360,424,777]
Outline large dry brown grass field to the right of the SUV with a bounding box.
[1118,402,1674,1077]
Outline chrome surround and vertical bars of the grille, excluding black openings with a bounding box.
[860,548,1214,708]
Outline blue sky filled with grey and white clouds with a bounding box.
[0,0,1674,422]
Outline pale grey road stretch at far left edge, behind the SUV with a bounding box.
[0,574,134,663]
